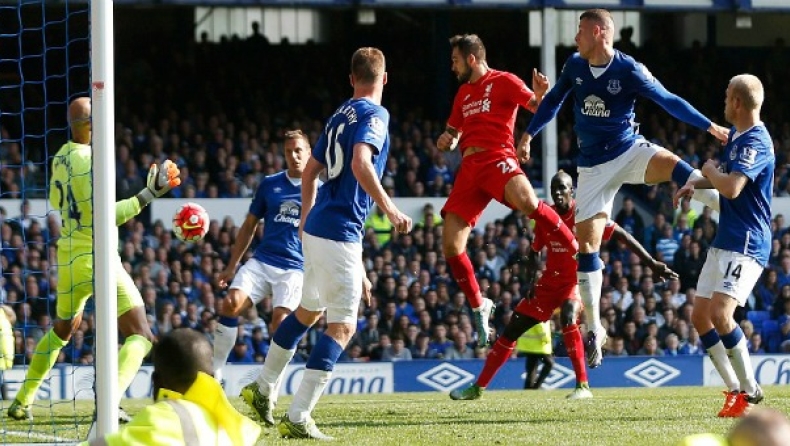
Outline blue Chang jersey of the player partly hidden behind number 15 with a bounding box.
[250,172,304,270]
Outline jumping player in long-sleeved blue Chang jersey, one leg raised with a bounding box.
[518,9,727,368]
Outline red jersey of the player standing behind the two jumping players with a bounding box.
[532,201,617,286]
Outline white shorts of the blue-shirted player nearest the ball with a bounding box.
[230,258,304,311]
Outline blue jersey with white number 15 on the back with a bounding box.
[304,98,390,242]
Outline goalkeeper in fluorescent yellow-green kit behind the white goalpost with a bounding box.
[8,98,181,421]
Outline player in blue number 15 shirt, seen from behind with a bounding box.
[243,48,412,439]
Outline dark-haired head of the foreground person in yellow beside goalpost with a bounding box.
[153,328,214,393]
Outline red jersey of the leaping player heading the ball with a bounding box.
[447,69,535,155]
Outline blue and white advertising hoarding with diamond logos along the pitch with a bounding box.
[4,355,790,400]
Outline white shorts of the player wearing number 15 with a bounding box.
[300,232,364,326]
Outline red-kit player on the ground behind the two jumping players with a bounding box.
[450,171,678,400]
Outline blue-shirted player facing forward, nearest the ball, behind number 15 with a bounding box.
[214,130,310,384]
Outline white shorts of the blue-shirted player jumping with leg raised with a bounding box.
[576,138,665,223]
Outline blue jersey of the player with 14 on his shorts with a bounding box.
[712,123,776,266]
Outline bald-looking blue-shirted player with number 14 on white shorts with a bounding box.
[675,74,776,417]
